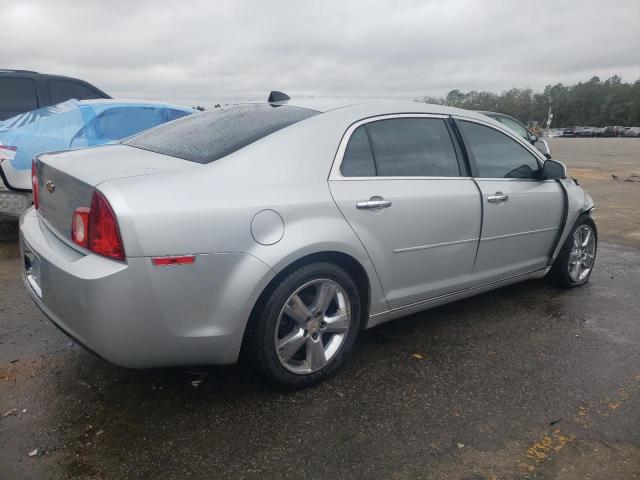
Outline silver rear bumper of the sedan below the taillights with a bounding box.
[20,210,273,368]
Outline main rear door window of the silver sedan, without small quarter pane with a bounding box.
[366,118,460,177]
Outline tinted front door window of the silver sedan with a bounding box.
[458,121,540,178]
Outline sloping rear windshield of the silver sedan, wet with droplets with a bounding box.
[124,104,319,163]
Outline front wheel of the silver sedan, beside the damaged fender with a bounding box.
[547,215,598,288]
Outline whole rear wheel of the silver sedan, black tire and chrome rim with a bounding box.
[253,262,362,389]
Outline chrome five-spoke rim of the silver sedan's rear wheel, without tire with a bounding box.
[274,279,351,375]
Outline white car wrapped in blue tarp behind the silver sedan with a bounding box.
[0,100,196,215]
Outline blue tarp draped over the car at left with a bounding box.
[0,100,196,170]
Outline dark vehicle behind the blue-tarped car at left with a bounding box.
[0,69,111,121]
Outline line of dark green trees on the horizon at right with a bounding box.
[418,75,640,128]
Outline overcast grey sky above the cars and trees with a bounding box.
[0,0,640,105]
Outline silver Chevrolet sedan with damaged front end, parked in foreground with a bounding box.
[20,95,597,388]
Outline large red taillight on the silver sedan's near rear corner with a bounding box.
[71,190,124,260]
